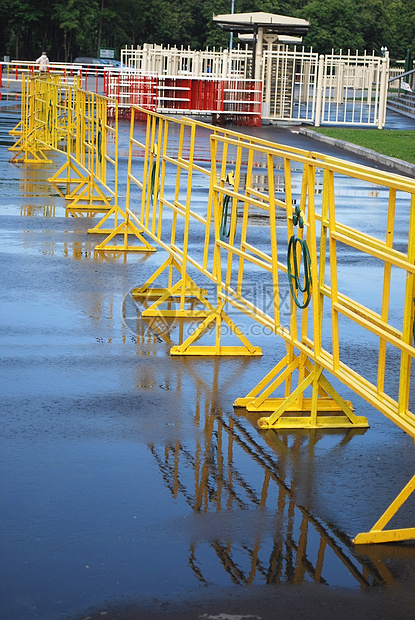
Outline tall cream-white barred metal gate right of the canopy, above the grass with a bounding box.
[262,49,389,129]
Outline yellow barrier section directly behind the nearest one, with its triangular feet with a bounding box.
[127,109,261,355]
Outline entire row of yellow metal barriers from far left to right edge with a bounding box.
[8,77,415,543]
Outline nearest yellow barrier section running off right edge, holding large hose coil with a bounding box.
[206,136,415,544]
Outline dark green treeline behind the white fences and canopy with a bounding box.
[0,0,415,62]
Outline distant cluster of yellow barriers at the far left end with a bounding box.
[10,74,125,223]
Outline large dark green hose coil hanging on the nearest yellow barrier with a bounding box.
[287,206,312,310]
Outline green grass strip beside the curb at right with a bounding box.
[313,127,415,164]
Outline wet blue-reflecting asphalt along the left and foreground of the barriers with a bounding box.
[0,94,415,620]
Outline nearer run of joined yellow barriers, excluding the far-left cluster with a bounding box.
[118,108,415,543]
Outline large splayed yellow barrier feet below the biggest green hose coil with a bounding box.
[234,355,369,429]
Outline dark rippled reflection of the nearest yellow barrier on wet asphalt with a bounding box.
[145,360,394,590]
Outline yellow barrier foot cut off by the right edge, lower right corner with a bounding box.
[353,476,415,545]
